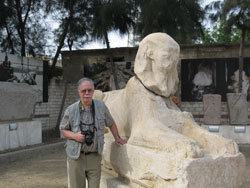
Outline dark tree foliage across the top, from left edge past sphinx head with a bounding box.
[0,0,207,58]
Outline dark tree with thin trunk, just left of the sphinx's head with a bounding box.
[91,0,134,89]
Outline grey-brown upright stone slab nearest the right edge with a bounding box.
[227,93,249,125]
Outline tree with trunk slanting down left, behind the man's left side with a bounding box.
[48,0,90,79]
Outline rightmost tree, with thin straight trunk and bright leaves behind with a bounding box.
[207,0,250,93]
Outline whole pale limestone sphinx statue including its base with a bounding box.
[94,33,245,188]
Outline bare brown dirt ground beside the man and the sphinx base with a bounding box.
[0,147,250,188]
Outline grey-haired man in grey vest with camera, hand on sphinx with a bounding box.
[60,78,126,188]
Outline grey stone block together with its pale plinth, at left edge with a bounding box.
[0,82,42,151]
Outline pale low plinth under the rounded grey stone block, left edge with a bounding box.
[0,121,42,151]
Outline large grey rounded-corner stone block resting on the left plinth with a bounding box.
[0,82,36,121]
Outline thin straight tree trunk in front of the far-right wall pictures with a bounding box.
[239,28,245,93]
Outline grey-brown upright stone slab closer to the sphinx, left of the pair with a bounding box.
[203,94,221,125]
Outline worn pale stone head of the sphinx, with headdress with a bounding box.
[134,33,180,97]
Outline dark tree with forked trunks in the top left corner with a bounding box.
[1,0,46,56]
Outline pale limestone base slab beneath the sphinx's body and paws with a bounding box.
[102,136,245,188]
